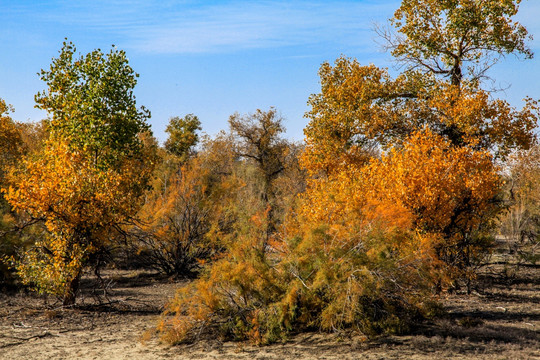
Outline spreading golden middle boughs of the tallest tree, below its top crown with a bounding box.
[303,57,538,177]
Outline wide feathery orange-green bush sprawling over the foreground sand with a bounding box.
[158,136,442,344]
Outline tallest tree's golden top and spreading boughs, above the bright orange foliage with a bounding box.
[305,0,538,174]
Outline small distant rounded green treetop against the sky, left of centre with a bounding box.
[165,114,201,159]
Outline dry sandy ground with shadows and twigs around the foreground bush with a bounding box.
[0,266,540,360]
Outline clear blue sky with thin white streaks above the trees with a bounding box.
[0,0,540,141]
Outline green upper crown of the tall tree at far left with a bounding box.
[35,41,150,166]
